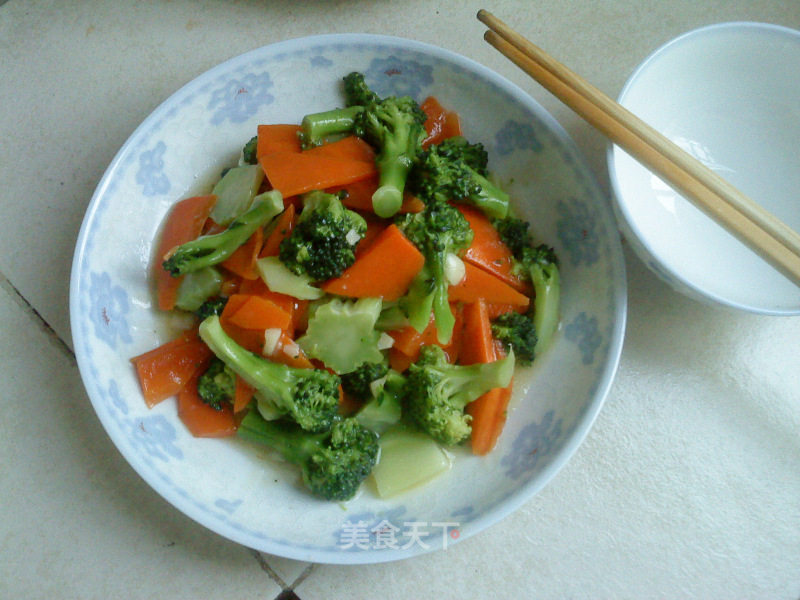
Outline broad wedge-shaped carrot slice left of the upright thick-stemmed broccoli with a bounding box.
[259,151,377,197]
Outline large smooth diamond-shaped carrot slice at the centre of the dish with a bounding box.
[321,224,425,301]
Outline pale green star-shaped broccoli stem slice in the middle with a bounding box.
[297,298,383,373]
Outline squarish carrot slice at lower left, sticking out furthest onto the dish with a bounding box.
[131,331,212,408]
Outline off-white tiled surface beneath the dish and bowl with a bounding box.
[0,0,800,600]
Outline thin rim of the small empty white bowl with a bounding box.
[606,21,800,316]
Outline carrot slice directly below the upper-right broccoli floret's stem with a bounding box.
[456,204,531,293]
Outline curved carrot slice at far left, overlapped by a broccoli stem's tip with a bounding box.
[152,194,217,310]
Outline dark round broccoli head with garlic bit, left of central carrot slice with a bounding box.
[278,191,367,281]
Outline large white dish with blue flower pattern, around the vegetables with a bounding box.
[70,34,626,563]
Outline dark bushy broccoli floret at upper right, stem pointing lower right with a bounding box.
[410,140,509,218]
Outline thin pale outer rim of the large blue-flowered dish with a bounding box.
[69,33,627,564]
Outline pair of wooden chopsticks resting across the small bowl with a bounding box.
[478,10,800,286]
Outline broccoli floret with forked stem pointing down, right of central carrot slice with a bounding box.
[398,202,473,344]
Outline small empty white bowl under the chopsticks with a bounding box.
[608,23,800,315]
